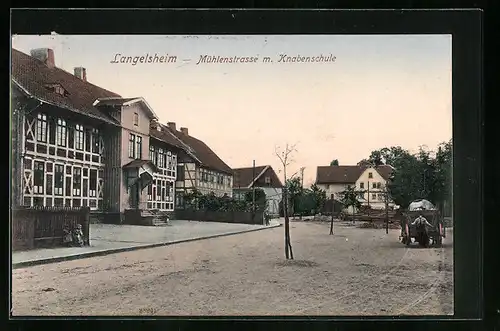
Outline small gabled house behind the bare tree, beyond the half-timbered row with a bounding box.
[233,165,283,215]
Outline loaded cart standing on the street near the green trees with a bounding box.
[400,200,446,247]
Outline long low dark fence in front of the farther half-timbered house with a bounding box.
[175,209,264,225]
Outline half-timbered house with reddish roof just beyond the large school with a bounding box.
[160,122,233,208]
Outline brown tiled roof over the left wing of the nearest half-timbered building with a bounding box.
[12,49,120,124]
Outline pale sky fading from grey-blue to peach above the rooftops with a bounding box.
[12,34,452,185]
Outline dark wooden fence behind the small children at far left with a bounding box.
[11,207,90,251]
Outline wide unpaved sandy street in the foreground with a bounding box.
[12,222,453,316]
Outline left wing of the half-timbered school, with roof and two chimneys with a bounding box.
[11,49,120,215]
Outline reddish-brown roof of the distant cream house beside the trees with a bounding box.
[316,165,393,184]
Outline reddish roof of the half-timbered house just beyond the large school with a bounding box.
[169,126,233,175]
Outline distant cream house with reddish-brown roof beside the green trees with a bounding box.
[316,165,394,209]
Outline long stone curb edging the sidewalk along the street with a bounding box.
[12,224,283,269]
